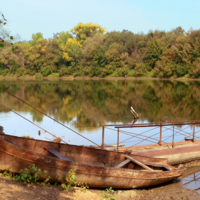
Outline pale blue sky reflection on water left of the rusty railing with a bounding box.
[0,112,101,145]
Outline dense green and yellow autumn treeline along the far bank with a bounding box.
[0,23,200,78]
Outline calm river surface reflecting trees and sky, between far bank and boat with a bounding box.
[0,80,200,191]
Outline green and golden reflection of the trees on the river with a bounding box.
[0,81,200,130]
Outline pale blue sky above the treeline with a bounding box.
[0,0,200,40]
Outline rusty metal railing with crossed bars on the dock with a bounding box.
[101,120,200,151]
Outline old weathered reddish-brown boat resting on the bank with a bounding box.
[0,134,184,188]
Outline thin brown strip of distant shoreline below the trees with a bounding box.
[0,76,200,81]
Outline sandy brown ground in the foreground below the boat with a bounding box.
[0,176,200,200]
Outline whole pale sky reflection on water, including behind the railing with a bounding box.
[0,112,200,146]
